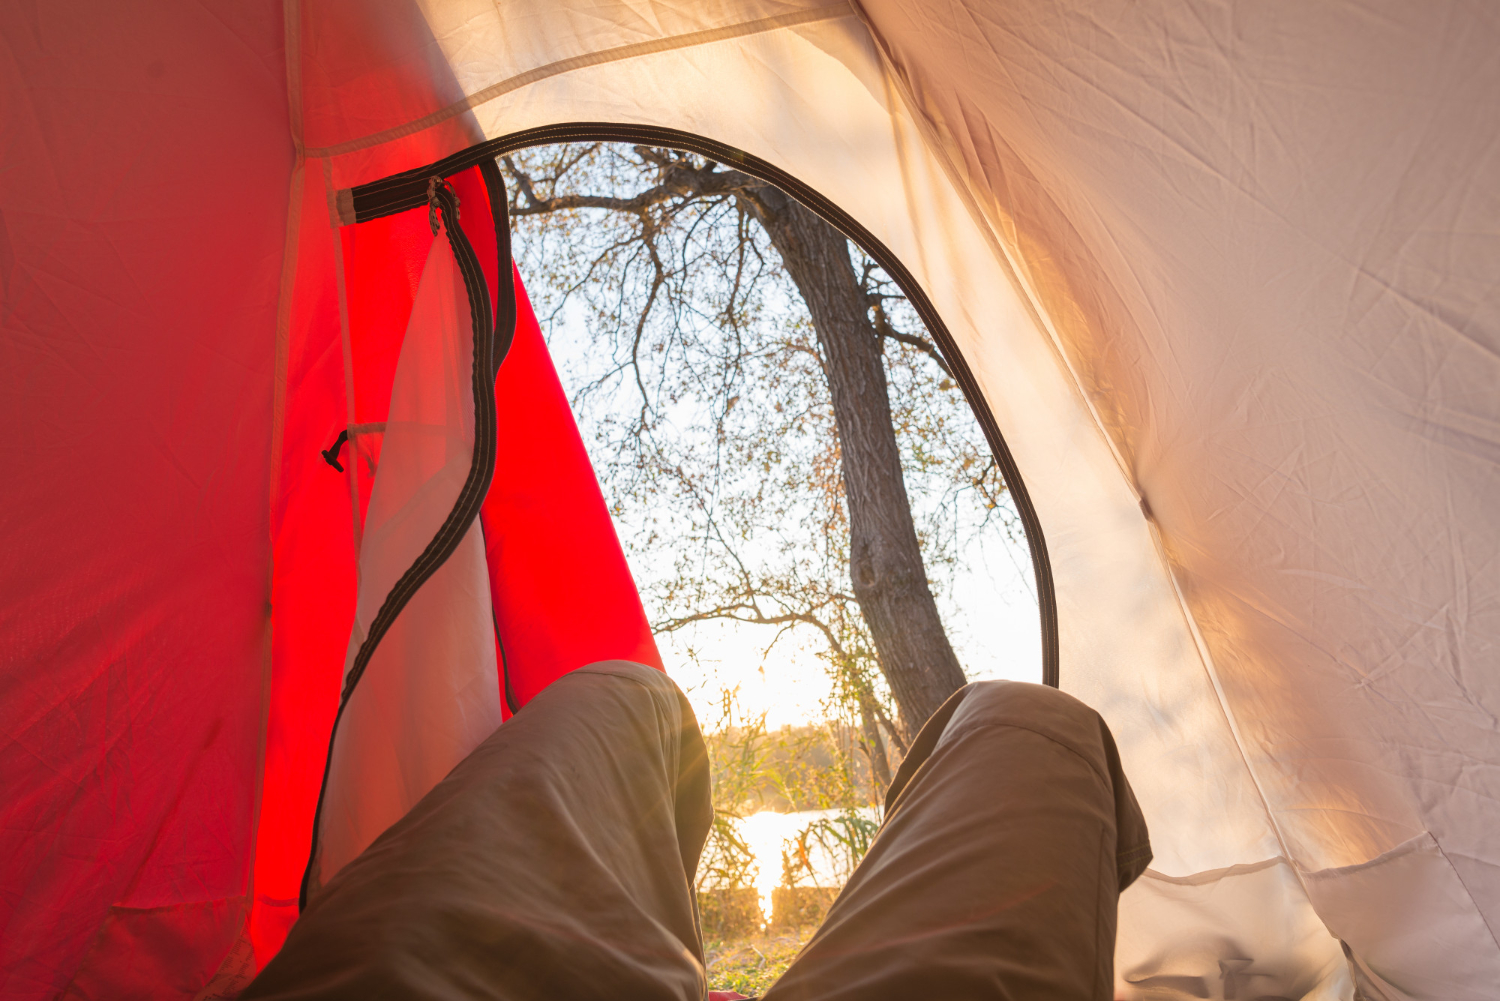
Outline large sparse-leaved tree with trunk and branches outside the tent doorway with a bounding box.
[503,144,1004,762]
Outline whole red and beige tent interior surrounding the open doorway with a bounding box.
[0,0,1500,1001]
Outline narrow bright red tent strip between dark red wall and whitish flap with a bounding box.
[259,125,359,965]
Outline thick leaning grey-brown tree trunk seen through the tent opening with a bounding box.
[746,188,965,735]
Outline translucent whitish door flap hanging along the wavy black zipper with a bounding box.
[316,236,501,894]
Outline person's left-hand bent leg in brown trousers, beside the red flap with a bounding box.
[242,662,713,1001]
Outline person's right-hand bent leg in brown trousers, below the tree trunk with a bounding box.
[765,681,1151,1001]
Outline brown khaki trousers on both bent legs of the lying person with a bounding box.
[252,662,1151,1001]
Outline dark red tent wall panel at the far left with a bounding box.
[0,0,294,998]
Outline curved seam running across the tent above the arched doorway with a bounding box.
[308,0,855,156]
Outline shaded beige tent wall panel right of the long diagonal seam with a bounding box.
[867,0,1500,996]
